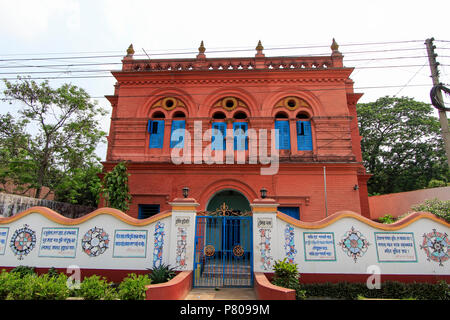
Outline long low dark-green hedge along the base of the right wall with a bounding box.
[301,281,450,300]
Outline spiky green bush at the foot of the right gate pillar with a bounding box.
[272,258,306,299]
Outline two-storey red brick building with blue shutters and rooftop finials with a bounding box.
[103,40,370,221]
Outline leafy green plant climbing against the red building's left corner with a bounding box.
[102,161,131,212]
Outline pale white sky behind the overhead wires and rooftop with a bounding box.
[0,0,450,159]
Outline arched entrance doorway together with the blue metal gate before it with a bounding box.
[193,189,253,287]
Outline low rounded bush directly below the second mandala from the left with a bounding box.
[77,275,117,300]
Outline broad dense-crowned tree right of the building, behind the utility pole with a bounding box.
[357,96,450,194]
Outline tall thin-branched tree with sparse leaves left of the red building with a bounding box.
[0,78,106,202]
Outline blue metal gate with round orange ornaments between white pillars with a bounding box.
[194,216,253,287]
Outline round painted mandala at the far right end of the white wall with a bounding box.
[420,229,450,267]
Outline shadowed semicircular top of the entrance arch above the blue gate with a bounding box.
[206,189,251,212]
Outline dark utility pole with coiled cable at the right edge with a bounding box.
[425,38,450,168]
